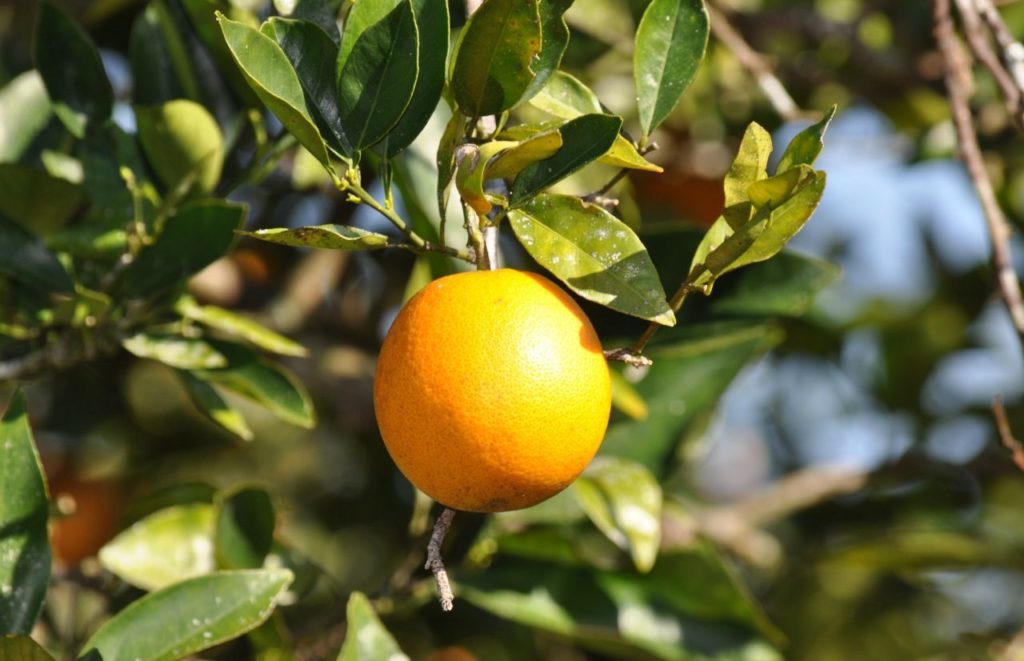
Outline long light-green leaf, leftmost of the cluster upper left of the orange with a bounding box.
[217,12,331,167]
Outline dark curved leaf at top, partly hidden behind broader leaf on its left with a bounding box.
[382,0,451,159]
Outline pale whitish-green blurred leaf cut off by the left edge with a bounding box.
[0,70,52,162]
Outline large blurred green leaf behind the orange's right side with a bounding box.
[600,322,781,475]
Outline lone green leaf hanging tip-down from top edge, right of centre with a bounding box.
[633,0,709,137]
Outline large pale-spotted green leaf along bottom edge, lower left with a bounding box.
[79,569,292,661]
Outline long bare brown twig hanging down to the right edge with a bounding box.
[933,0,1024,342]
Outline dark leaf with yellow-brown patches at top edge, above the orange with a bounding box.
[451,0,541,117]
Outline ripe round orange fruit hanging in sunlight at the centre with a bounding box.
[374,269,611,512]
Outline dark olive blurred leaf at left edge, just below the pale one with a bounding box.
[0,163,85,236]
